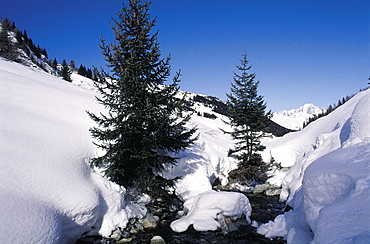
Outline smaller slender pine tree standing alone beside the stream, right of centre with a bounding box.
[226,53,271,180]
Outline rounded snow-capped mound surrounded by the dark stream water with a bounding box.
[171,191,252,232]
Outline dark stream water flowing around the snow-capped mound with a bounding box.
[77,194,286,244]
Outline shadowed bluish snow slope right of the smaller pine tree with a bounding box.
[259,89,370,243]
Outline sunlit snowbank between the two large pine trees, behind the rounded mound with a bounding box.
[163,115,236,207]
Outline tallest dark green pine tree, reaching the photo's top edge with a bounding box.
[88,0,196,195]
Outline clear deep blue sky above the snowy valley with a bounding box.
[0,0,370,111]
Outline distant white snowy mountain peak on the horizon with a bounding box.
[272,103,324,130]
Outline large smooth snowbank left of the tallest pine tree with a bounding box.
[0,60,145,243]
